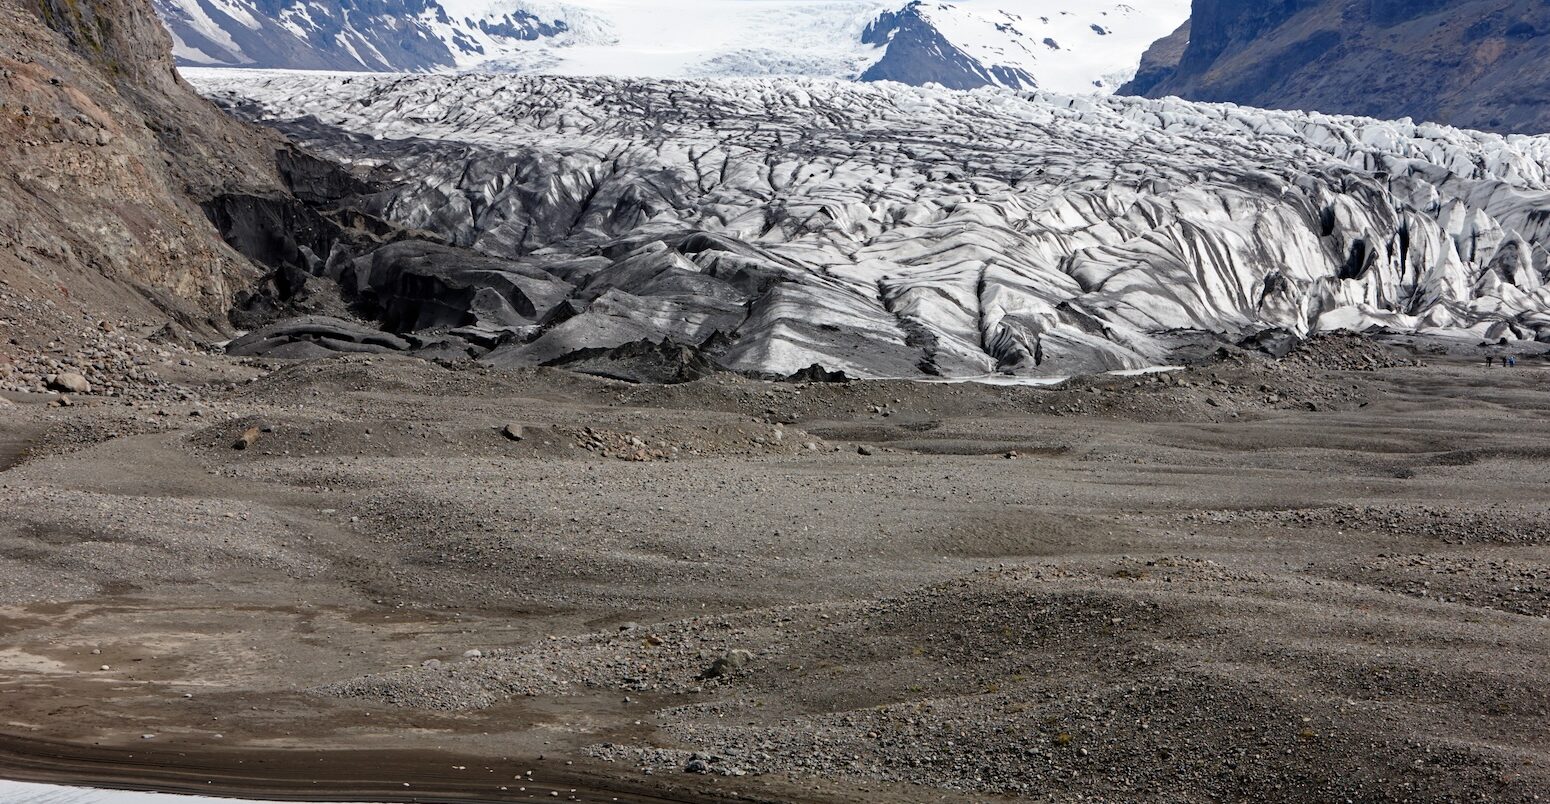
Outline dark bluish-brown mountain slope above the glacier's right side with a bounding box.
[1121,0,1550,133]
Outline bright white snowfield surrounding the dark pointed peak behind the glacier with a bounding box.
[450,0,1189,93]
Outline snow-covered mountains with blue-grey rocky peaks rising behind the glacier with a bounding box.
[155,0,1189,91]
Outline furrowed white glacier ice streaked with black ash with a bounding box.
[191,71,1550,378]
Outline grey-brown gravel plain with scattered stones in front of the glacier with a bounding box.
[0,341,1550,801]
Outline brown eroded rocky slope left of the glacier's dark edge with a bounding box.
[0,0,281,342]
